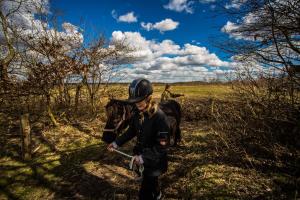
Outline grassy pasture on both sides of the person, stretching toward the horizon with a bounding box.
[0,84,291,199]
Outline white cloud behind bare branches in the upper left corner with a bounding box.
[0,0,83,57]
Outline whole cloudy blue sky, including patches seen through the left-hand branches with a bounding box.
[0,0,246,82]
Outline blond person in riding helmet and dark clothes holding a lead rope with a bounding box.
[108,79,170,200]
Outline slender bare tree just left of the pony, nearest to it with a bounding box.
[82,36,130,112]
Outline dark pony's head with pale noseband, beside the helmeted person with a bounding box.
[102,99,132,143]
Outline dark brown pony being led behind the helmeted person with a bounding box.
[102,99,181,145]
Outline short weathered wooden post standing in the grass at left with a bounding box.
[20,114,31,161]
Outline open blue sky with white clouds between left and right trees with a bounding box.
[50,0,238,82]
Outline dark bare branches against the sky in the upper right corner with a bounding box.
[218,0,300,77]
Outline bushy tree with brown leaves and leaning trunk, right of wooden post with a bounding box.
[14,7,82,125]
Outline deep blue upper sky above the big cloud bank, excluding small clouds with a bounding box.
[51,0,227,51]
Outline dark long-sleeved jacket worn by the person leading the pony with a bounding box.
[115,108,170,176]
